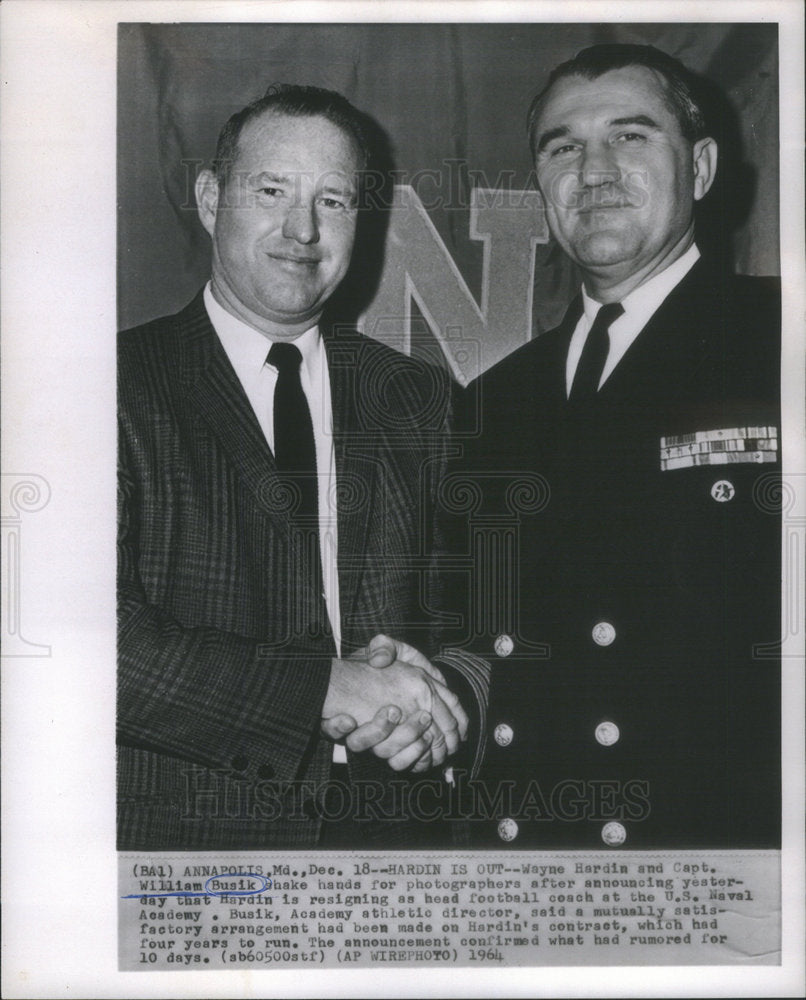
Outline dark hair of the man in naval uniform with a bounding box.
[526,43,707,150]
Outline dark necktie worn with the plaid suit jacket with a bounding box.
[266,342,322,591]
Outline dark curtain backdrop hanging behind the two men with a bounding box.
[118,24,779,377]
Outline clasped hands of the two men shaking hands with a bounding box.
[321,635,468,772]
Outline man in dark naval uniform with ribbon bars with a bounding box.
[462,45,780,850]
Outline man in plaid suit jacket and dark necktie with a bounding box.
[118,87,478,850]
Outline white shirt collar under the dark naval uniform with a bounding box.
[565,243,700,396]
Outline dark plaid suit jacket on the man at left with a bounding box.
[118,294,474,849]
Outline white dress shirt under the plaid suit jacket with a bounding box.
[204,282,347,761]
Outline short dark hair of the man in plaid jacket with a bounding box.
[213,83,370,187]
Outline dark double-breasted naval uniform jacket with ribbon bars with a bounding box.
[453,260,781,850]
